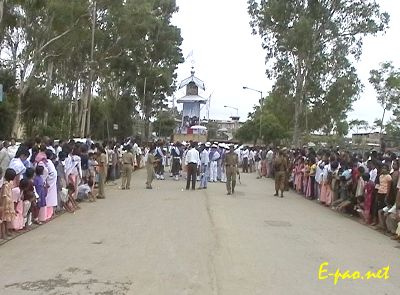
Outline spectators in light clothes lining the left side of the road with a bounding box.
[0,137,142,239]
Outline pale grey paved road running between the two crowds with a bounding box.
[0,170,400,295]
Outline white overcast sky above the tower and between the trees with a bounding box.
[173,0,400,130]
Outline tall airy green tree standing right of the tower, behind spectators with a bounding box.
[248,0,389,146]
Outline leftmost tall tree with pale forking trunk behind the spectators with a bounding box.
[3,0,86,136]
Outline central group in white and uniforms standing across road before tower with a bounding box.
[145,141,241,195]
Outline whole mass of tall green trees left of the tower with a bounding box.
[0,0,183,139]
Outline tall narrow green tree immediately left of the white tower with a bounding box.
[126,0,183,139]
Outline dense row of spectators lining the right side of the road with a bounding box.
[257,148,400,241]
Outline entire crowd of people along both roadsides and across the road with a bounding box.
[0,137,400,245]
